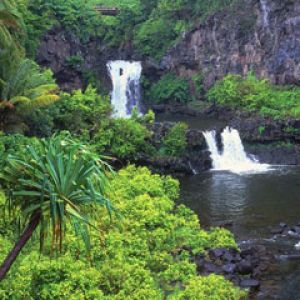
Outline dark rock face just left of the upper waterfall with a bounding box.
[36,27,137,91]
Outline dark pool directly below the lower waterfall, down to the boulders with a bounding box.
[180,168,300,239]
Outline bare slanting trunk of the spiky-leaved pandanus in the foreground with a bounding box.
[0,212,41,281]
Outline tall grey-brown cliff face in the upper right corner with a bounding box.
[161,0,300,89]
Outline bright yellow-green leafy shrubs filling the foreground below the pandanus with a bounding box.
[0,166,245,300]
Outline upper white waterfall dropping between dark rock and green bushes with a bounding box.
[107,60,142,118]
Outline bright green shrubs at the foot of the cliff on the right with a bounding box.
[208,73,300,118]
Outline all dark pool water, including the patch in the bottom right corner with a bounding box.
[180,168,300,300]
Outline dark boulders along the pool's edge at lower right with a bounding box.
[183,222,300,300]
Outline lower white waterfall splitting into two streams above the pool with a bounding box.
[203,127,268,174]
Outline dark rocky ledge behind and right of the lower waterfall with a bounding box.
[152,102,300,165]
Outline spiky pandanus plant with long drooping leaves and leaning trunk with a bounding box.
[0,136,113,281]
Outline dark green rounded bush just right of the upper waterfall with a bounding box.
[147,74,192,103]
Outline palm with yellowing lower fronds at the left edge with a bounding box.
[0,59,59,130]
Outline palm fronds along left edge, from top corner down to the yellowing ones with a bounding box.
[0,1,58,131]
